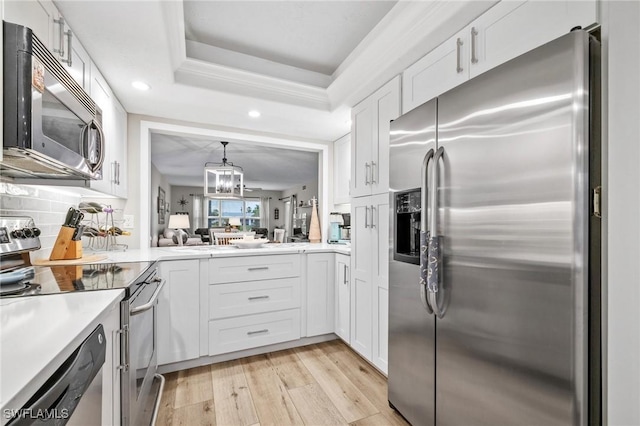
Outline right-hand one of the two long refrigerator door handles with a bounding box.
[427,147,446,319]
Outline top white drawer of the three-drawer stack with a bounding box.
[209,254,300,284]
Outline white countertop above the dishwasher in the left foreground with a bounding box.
[0,289,124,416]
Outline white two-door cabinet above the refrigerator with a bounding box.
[402,0,596,113]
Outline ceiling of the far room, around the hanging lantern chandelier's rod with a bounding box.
[151,132,318,191]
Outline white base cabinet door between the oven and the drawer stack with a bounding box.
[158,259,200,365]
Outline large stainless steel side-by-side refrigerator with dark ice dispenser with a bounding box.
[389,30,600,426]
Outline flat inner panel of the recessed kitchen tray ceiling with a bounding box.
[184,0,396,77]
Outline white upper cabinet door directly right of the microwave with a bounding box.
[90,63,114,194]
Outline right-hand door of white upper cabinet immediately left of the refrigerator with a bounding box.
[371,76,400,194]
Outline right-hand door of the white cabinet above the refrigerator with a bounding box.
[468,0,596,77]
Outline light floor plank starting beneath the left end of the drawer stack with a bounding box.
[211,360,258,426]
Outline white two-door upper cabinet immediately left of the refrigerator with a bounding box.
[351,76,400,197]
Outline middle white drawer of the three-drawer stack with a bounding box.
[209,277,300,319]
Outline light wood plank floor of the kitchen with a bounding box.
[157,340,407,426]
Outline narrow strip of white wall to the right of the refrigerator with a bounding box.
[600,1,640,425]
